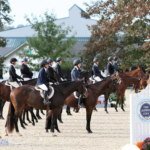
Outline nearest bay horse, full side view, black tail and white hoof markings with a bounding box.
[6,79,86,136]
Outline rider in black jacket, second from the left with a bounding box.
[20,58,33,81]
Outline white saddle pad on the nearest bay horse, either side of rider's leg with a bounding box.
[35,85,54,99]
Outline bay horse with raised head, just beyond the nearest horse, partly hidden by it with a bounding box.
[45,72,121,133]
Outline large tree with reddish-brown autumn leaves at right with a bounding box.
[82,0,150,70]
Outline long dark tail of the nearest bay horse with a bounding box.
[7,99,15,133]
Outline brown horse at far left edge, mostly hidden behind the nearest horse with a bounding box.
[0,79,37,128]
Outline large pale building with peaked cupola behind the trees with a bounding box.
[0,4,97,79]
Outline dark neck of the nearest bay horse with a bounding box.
[63,82,80,98]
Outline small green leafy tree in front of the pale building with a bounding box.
[27,12,77,70]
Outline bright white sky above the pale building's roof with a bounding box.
[9,0,93,27]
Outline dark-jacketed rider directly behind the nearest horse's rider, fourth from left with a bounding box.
[46,58,57,83]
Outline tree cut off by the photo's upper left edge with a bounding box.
[0,0,13,47]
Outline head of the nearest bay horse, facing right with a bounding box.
[76,78,88,98]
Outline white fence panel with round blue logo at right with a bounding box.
[130,84,150,144]
